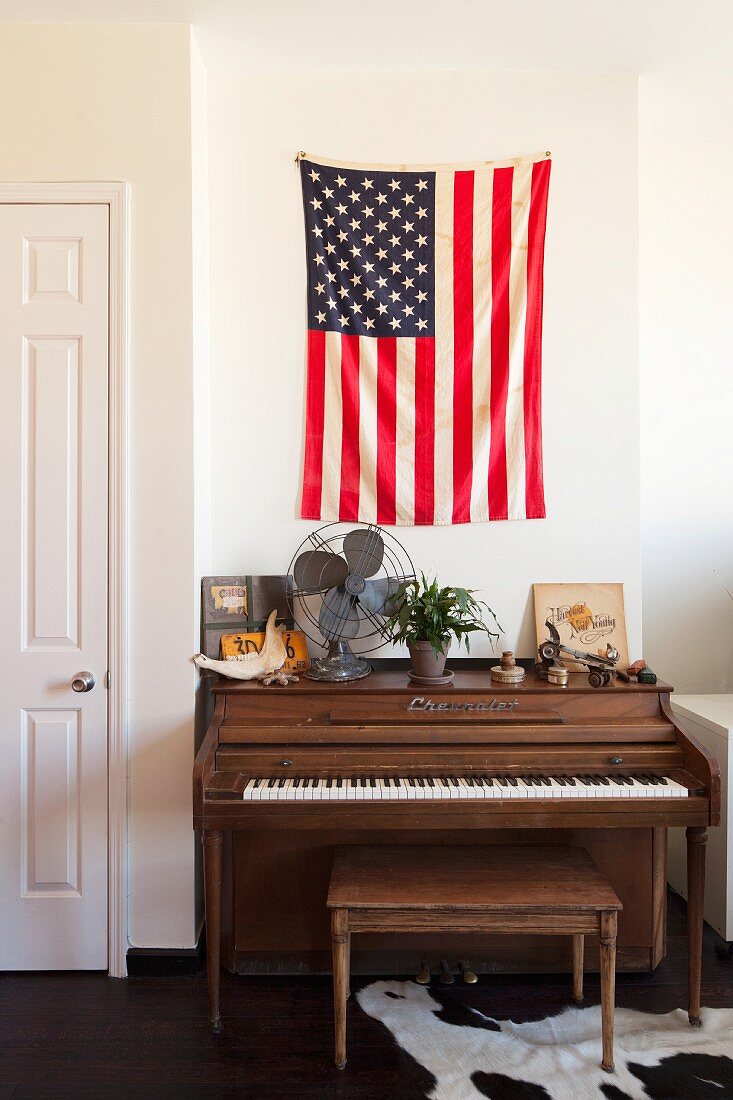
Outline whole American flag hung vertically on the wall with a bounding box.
[300,154,550,526]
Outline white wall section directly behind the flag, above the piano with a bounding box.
[209,73,641,656]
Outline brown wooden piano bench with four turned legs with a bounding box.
[328,845,623,1073]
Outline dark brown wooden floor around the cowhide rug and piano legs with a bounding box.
[0,897,733,1100]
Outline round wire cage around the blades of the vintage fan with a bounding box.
[287,521,416,653]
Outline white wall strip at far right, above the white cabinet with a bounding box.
[639,70,733,693]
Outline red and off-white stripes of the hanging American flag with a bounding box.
[300,154,550,526]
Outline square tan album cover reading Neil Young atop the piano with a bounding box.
[533,583,630,672]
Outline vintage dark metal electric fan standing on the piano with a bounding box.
[288,524,415,681]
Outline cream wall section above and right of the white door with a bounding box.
[0,25,197,947]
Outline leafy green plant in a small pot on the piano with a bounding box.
[382,573,502,680]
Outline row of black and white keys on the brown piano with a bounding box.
[242,774,688,802]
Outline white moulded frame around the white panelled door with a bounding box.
[0,182,130,978]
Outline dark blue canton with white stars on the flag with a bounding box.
[300,160,435,337]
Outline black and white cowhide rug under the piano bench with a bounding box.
[357,981,733,1100]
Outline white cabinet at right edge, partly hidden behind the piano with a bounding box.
[668,695,733,941]
